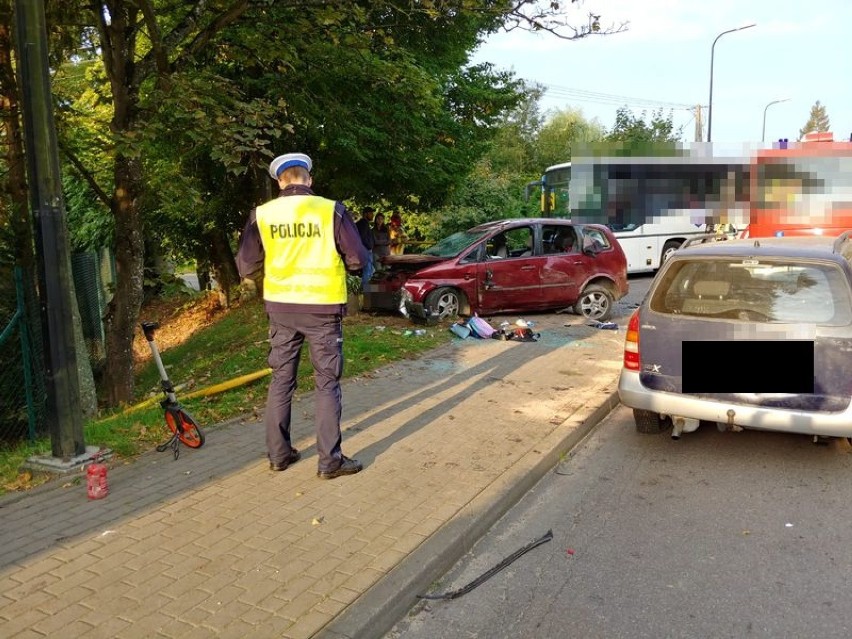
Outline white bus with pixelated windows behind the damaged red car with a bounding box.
[541,156,748,273]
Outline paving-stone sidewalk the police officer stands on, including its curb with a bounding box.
[0,313,626,638]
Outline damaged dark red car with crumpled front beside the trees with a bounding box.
[363,218,628,321]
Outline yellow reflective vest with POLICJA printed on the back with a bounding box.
[256,195,346,304]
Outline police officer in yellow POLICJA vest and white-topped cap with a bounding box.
[237,153,369,479]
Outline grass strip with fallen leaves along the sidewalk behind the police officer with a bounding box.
[0,295,452,494]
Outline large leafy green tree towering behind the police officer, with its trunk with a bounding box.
[38,0,623,404]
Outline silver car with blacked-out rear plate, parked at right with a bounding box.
[618,231,852,438]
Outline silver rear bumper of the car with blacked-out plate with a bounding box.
[618,369,852,437]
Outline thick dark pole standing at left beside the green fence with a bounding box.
[15,0,86,460]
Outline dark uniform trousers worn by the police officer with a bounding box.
[264,313,343,471]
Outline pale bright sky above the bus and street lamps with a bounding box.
[474,0,852,151]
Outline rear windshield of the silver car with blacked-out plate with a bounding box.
[650,259,852,326]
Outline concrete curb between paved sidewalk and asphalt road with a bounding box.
[314,391,618,639]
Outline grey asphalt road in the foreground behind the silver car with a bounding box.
[387,407,852,639]
